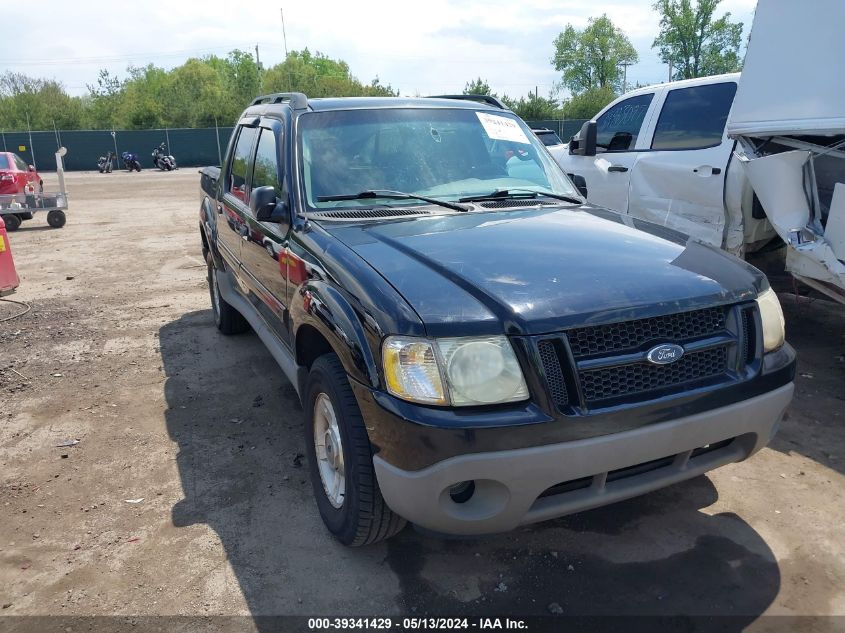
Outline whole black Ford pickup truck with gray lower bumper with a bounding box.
[199,93,795,545]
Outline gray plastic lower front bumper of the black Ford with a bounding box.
[373,383,793,534]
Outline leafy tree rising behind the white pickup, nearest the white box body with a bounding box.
[652,0,742,79]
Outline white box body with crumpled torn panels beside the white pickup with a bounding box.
[727,0,845,303]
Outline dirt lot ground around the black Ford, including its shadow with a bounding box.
[0,169,845,631]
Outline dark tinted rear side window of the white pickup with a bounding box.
[651,81,736,149]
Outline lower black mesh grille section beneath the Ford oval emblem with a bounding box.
[580,347,728,402]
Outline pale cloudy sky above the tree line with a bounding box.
[0,0,756,97]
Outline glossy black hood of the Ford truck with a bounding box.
[323,205,767,336]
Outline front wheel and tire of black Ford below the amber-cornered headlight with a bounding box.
[305,354,406,547]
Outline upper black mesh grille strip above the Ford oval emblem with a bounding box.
[566,307,725,358]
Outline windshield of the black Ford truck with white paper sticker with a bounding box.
[299,108,579,209]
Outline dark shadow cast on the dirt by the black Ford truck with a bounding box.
[159,310,781,631]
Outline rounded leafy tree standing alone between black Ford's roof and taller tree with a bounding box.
[552,15,639,94]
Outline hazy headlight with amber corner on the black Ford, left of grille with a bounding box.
[383,336,528,406]
